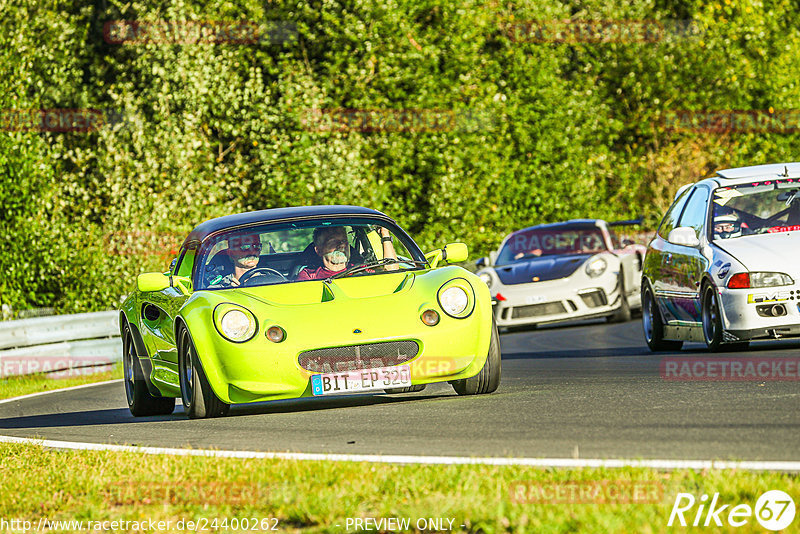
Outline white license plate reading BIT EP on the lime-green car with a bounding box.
[311,365,411,395]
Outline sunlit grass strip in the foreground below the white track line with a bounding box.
[0,444,800,533]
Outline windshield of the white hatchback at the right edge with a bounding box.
[711,178,800,239]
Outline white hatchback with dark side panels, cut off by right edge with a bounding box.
[641,163,800,351]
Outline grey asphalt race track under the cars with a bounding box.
[0,320,800,460]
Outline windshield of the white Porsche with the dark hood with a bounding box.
[496,226,606,265]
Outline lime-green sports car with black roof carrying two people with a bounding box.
[120,206,500,418]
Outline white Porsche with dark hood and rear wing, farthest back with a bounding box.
[477,219,645,327]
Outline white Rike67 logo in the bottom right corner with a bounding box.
[667,490,795,531]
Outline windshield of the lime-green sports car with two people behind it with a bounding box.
[195,218,425,289]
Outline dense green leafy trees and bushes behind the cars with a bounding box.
[0,0,800,312]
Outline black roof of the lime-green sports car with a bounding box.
[183,206,394,245]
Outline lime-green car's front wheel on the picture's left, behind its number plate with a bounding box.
[178,326,231,419]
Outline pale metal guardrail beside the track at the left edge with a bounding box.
[0,311,122,377]
